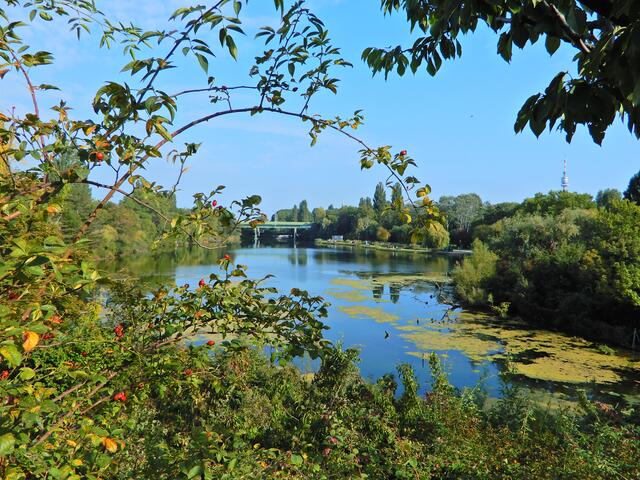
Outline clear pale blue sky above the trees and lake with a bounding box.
[6,0,640,213]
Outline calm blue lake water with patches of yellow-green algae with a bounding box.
[107,247,640,401]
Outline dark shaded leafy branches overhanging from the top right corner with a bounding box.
[362,0,640,144]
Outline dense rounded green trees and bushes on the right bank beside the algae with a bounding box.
[454,175,640,345]
